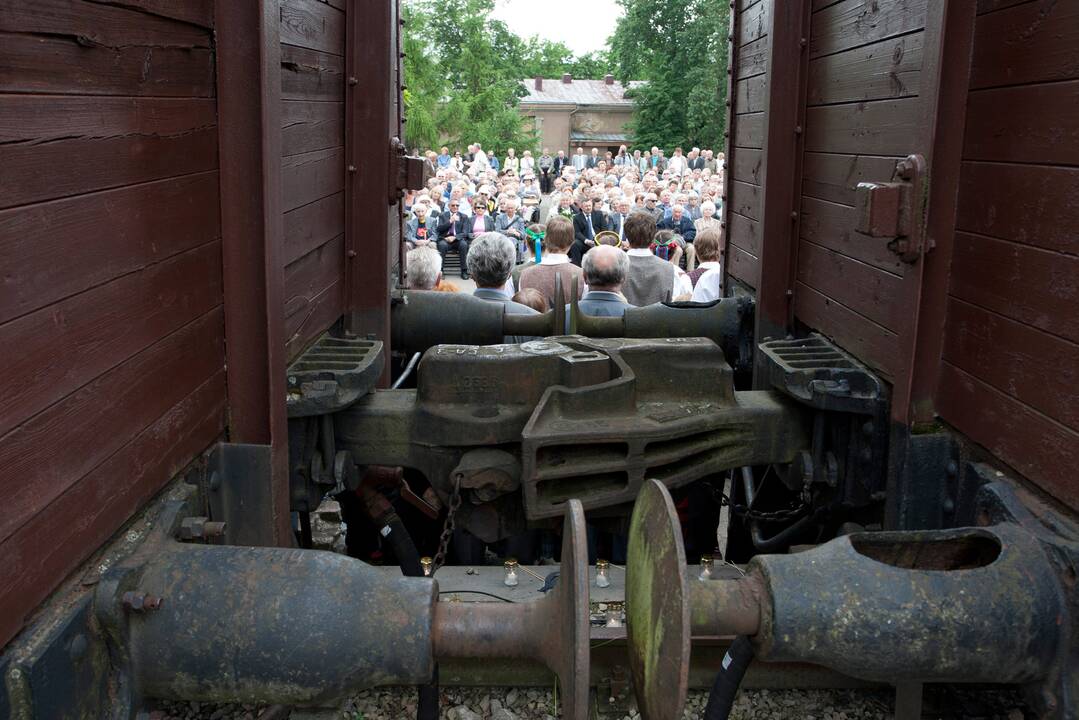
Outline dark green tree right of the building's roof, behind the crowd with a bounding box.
[609,0,729,150]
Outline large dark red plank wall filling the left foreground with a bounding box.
[0,0,226,646]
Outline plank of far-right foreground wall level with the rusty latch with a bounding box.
[956,162,1079,255]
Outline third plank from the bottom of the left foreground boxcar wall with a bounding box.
[0,241,221,436]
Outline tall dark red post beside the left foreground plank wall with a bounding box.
[215,0,291,545]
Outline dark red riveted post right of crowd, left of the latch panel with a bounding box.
[755,0,811,358]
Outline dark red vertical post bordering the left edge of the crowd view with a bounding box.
[345,0,397,385]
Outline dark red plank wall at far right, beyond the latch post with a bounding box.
[937,0,1079,510]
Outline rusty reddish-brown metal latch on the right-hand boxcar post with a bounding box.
[855,154,932,263]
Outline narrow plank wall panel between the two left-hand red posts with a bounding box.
[281,0,346,357]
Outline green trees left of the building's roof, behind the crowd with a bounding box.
[401,0,614,154]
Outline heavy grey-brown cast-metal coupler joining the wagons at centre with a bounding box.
[338,338,808,541]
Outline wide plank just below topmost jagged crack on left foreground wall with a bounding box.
[0,32,215,97]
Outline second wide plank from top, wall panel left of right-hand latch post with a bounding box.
[806,32,925,105]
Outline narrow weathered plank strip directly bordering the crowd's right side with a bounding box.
[724,0,775,288]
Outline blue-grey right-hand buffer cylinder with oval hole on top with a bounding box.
[627,474,1079,718]
